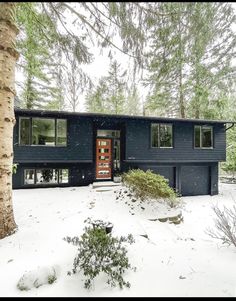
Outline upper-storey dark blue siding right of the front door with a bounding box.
[125,120,226,162]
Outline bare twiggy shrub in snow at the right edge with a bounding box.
[206,205,236,247]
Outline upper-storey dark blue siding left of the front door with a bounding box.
[14,116,93,162]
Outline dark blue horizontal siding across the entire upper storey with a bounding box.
[14,112,226,164]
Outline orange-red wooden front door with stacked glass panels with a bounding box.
[96,138,112,179]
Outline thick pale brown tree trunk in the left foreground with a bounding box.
[0,2,18,239]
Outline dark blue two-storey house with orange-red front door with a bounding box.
[13,109,234,196]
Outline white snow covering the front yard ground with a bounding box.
[0,184,236,297]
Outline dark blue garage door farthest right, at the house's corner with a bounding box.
[180,166,210,196]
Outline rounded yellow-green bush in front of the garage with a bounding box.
[122,169,177,207]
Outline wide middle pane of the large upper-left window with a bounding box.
[32,118,55,145]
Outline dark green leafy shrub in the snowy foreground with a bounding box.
[64,226,135,289]
